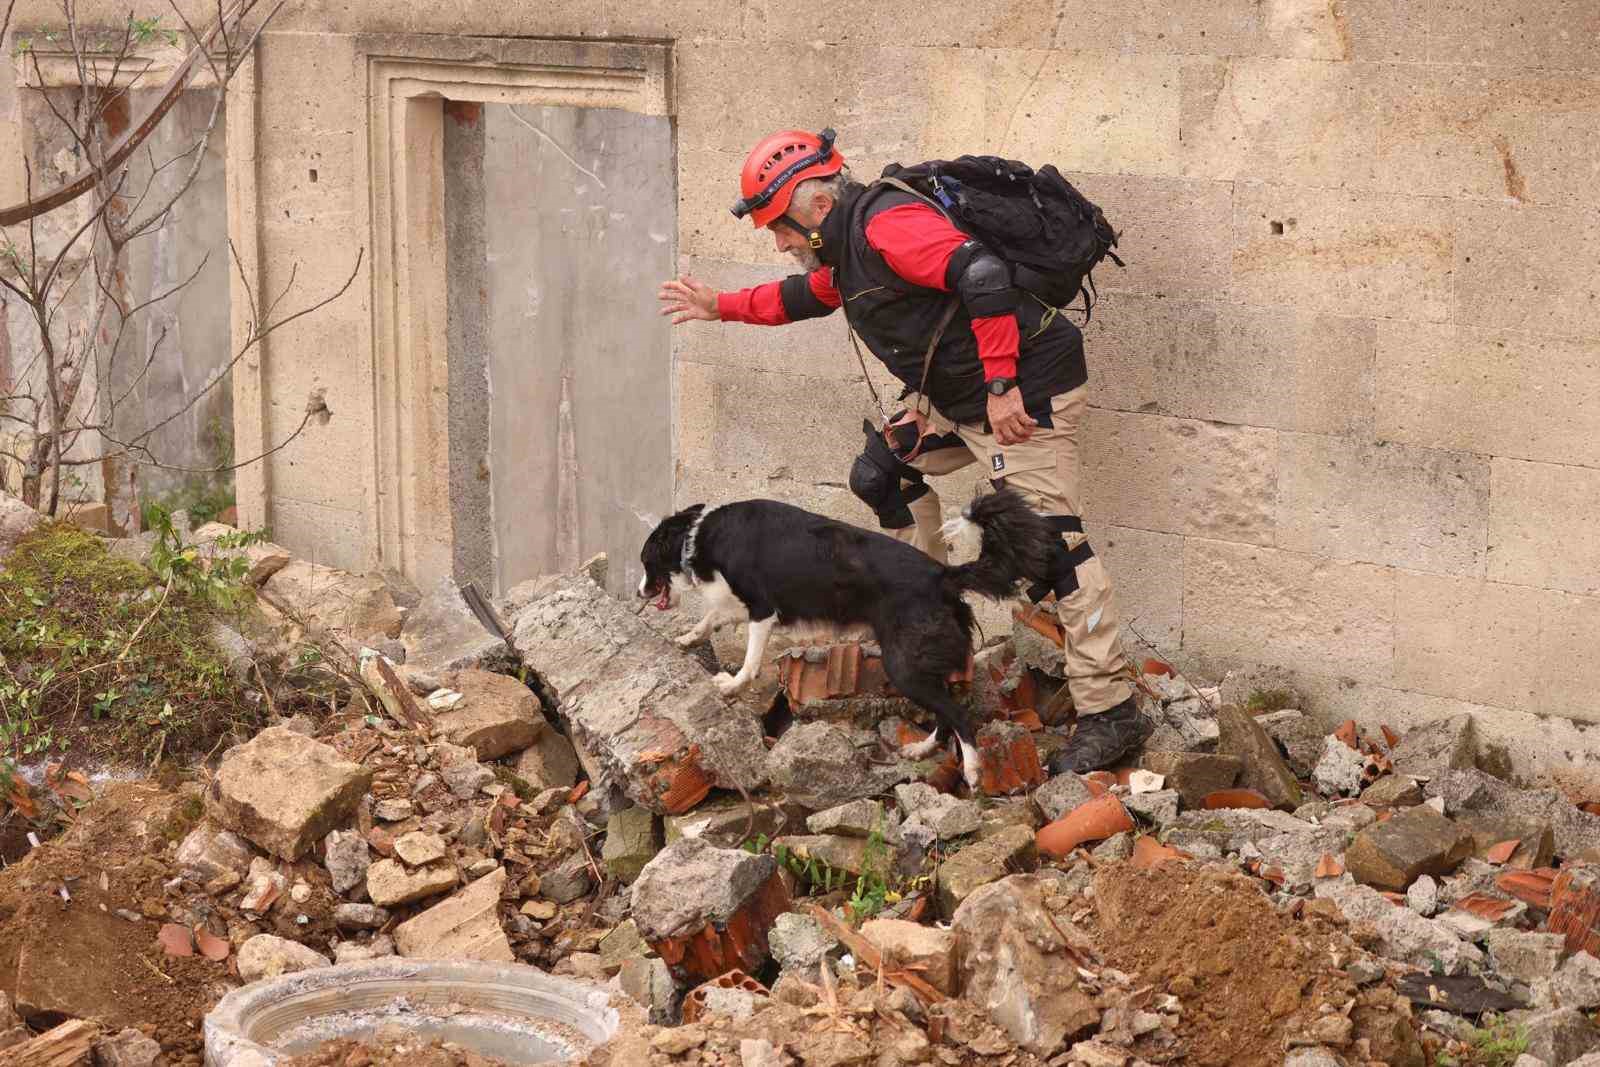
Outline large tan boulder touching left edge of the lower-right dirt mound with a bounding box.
[952,875,1101,1056]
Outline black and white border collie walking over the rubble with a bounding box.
[638,490,1059,787]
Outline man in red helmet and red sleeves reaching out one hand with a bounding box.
[661,131,1149,774]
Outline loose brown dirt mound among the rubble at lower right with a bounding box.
[1094,862,1422,1067]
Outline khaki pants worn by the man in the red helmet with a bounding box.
[885,386,1133,715]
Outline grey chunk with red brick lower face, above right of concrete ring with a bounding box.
[632,838,789,981]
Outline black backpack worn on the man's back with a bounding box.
[878,155,1123,322]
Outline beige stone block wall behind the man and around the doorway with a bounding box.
[9,0,1600,780]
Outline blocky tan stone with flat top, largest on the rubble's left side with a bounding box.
[205,726,373,862]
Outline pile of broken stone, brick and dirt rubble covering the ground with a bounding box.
[0,502,1600,1067]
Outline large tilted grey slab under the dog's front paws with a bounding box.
[512,576,764,814]
